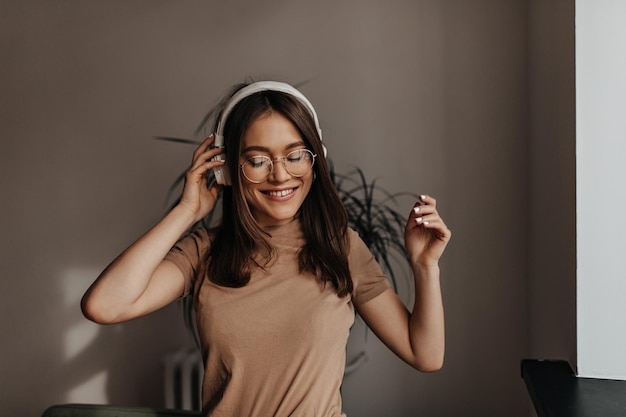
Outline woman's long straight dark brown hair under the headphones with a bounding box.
[205,85,353,297]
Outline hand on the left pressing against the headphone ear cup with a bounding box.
[178,135,224,222]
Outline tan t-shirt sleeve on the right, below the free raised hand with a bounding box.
[348,229,391,305]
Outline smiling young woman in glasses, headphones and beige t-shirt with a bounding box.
[82,82,451,417]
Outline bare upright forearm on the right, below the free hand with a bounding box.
[409,265,445,371]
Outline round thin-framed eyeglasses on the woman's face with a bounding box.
[240,149,317,184]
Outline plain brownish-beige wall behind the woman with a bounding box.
[0,0,567,417]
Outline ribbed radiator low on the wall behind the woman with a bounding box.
[164,348,204,411]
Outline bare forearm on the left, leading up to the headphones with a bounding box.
[82,207,194,321]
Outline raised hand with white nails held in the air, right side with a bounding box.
[404,195,452,267]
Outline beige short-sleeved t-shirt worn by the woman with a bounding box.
[167,220,390,417]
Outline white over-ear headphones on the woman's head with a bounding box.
[213,81,326,185]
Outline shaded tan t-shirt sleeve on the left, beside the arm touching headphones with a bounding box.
[165,228,210,297]
